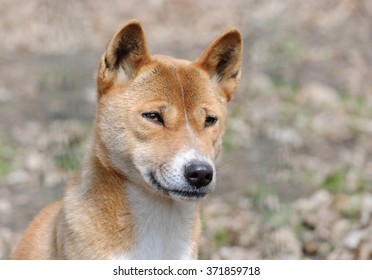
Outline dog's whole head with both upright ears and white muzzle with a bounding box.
[96,21,242,200]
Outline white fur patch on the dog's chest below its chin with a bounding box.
[117,188,196,259]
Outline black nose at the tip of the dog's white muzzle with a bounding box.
[185,162,213,188]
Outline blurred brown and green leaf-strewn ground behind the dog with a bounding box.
[0,0,372,259]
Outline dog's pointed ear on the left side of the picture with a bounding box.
[100,20,150,79]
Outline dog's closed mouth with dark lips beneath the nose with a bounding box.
[149,172,208,200]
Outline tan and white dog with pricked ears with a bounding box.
[12,20,243,260]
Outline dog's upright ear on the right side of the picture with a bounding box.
[196,29,243,101]
